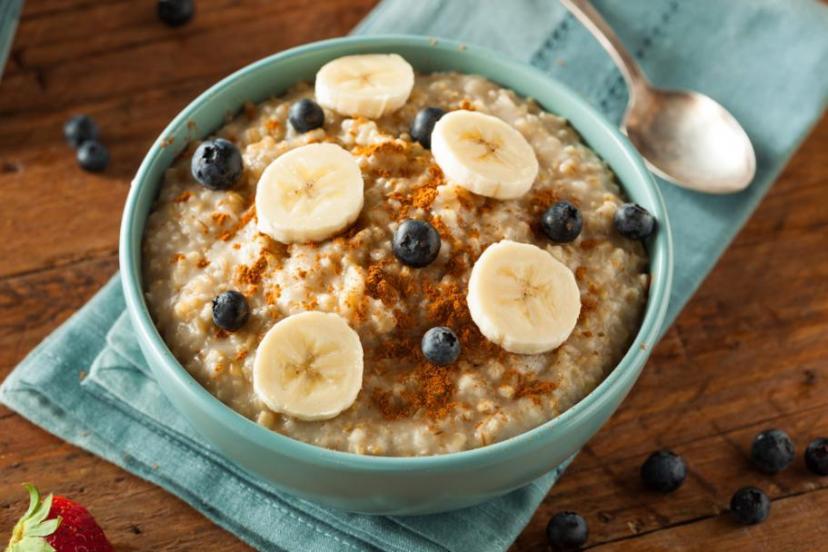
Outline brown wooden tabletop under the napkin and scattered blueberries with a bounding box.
[0,0,828,551]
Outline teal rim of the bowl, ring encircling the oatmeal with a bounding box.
[119,34,673,472]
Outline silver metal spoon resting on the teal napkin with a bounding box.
[561,0,756,194]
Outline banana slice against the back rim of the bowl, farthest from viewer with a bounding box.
[316,54,414,119]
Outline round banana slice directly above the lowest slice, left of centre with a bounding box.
[256,143,364,243]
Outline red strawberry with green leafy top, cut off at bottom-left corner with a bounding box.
[6,483,112,552]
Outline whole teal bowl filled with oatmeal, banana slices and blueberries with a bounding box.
[120,36,672,514]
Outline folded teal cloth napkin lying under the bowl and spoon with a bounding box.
[0,0,828,552]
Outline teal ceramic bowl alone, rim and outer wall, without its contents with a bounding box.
[120,36,673,514]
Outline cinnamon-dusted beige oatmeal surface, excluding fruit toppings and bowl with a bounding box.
[143,73,648,456]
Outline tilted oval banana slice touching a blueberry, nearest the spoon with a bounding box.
[431,110,538,199]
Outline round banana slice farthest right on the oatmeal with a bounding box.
[466,240,581,354]
